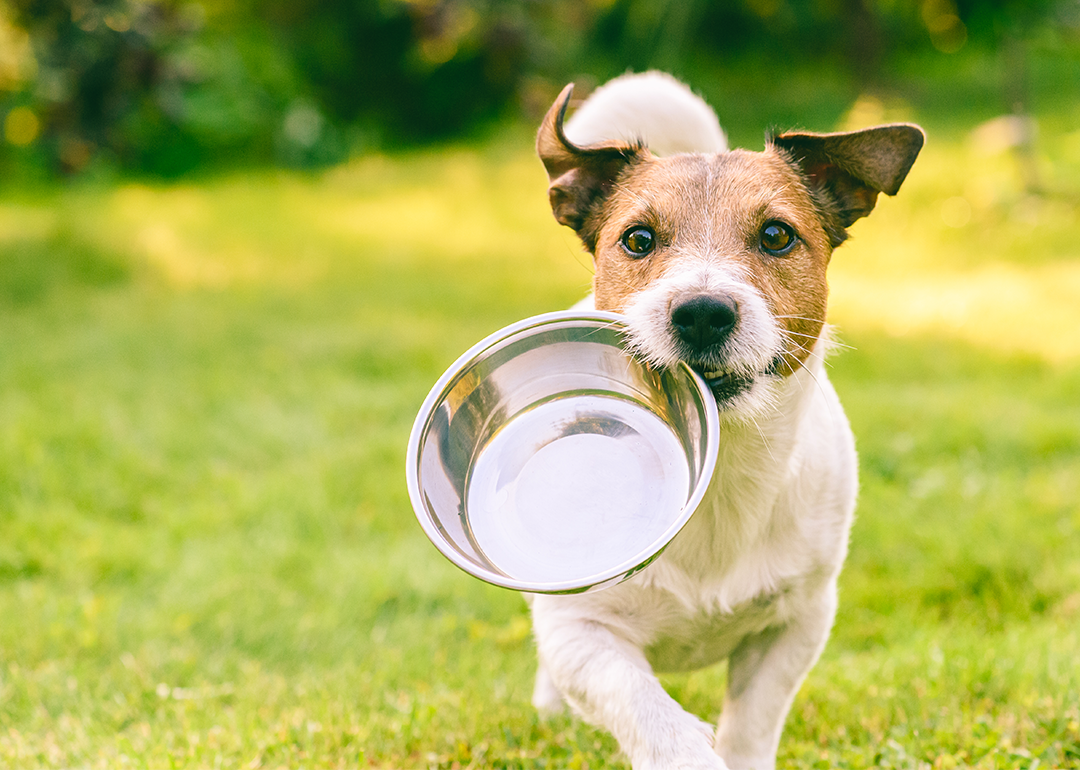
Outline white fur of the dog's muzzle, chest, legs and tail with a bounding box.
[530,73,856,770]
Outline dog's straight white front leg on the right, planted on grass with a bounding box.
[716,582,836,770]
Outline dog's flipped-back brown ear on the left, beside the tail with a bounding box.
[537,83,646,252]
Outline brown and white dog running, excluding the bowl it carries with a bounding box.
[530,72,923,770]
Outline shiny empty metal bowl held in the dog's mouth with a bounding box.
[406,311,718,593]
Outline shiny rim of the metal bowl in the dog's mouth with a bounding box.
[405,310,719,594]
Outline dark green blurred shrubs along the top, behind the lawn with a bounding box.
[0,0,1080,174]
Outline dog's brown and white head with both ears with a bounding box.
[537,85,923,409]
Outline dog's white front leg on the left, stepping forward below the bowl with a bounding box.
[532,597,725,770]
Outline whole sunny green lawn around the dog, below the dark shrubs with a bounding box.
[0,108,1080,768]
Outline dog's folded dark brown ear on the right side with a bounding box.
[770,123,926,247]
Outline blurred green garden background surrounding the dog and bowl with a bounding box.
[0,0,1080,770]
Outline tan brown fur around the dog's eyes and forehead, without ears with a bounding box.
[588,150,832,375]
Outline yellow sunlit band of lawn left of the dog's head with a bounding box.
[0,140,590,298]
